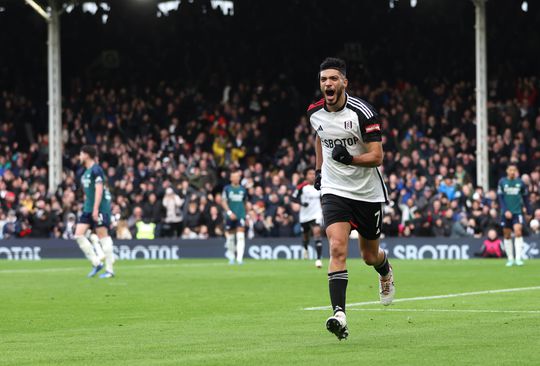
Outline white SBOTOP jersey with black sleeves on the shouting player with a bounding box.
[308,94,388,202]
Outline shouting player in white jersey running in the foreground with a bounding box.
[308,58,395,340]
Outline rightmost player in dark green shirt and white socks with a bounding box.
[497,164,532,267]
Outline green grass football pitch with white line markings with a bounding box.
[0,259,540,366]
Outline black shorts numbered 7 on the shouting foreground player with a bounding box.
[321,194,383,240]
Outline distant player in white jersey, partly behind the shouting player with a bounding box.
[292,168,322,268]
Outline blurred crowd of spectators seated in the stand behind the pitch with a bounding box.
[0,78,540,239]
